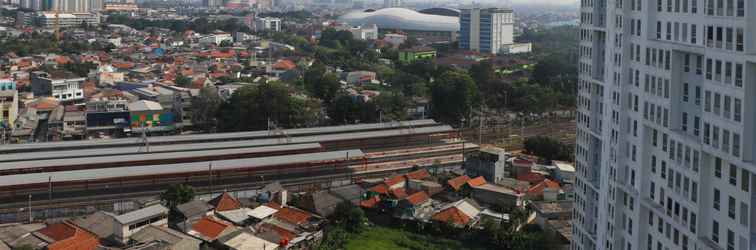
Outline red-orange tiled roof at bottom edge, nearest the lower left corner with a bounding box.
[38,222,100,250]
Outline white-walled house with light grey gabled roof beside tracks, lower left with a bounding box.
[113,204,168,244]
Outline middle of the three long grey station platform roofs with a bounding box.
[0,143,320,171]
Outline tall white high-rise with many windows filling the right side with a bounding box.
[572,0,756,250]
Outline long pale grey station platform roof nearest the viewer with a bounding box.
[0,150,365,187]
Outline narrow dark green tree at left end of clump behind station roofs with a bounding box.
[191,87,223,131]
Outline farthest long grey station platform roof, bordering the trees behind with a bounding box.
[0,119,437,153]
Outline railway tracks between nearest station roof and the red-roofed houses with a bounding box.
[0,154,462,223]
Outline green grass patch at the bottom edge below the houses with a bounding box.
[344,226,486,250]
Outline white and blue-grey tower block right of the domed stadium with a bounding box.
[459,8,529,54]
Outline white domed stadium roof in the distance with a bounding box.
[339,8,459,32]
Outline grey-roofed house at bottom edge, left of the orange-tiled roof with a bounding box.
[129,225,202,250]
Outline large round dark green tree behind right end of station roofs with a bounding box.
[430,71,480,124]
